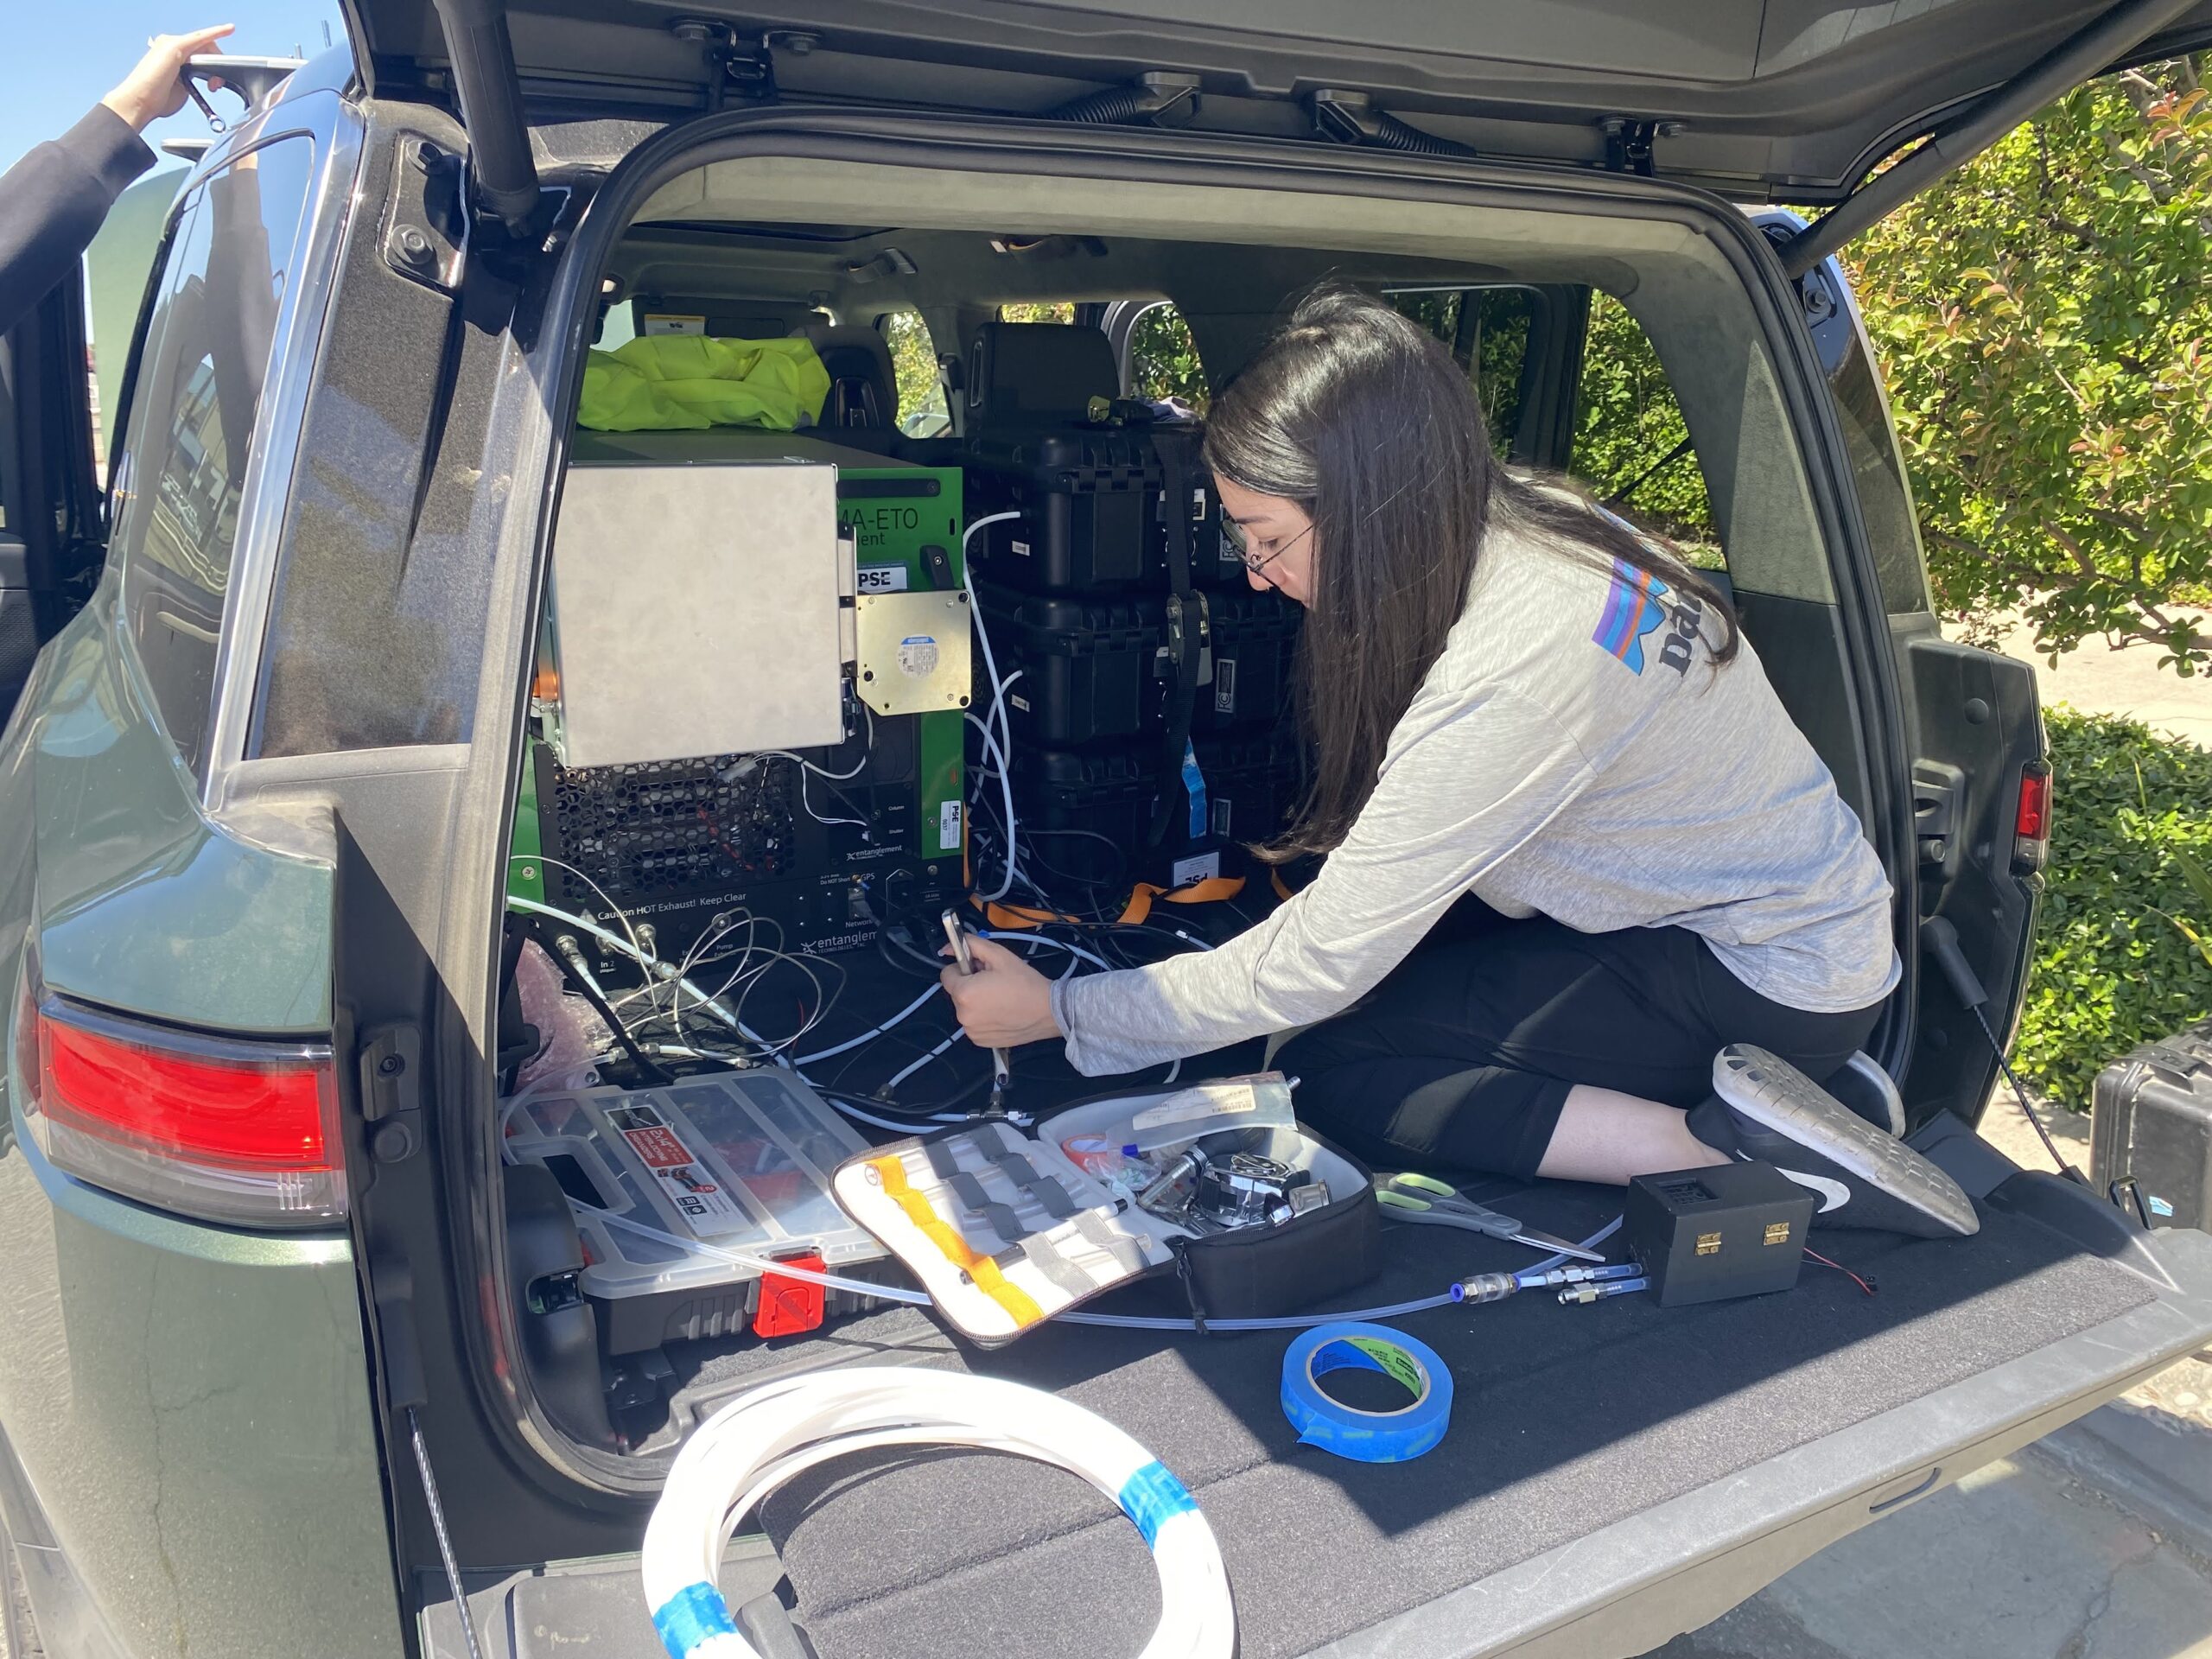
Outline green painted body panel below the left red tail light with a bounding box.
[0,1106,400,1659]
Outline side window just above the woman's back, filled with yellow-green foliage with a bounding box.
[1571,294,1723,569]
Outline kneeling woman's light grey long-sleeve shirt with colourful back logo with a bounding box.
[1053,524,1900,1075]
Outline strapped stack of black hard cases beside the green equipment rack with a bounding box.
[963,323,1300,887]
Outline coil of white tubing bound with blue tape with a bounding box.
[641,1365,1236,1659]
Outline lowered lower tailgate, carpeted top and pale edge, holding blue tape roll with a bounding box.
[420,1150,2212,1659]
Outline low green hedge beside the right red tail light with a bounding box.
[2013,708,2212,1110]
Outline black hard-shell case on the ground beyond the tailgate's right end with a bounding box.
[2090,1020,2212,1230]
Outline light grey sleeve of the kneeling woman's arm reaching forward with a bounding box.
[956,690,1591,1075]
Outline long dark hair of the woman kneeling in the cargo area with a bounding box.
[1205,285,1738,862]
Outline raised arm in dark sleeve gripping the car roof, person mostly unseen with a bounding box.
[0,22,230,334]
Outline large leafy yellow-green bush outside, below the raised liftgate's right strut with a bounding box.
[1847,60,2212,675]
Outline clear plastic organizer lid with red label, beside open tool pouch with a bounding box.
[506,1068,882,1296]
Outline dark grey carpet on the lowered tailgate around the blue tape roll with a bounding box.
[677,1184,2152,1659]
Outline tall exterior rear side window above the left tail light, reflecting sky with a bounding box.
[111,137,315,772]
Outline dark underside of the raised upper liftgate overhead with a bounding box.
[347,0,2212,204]
